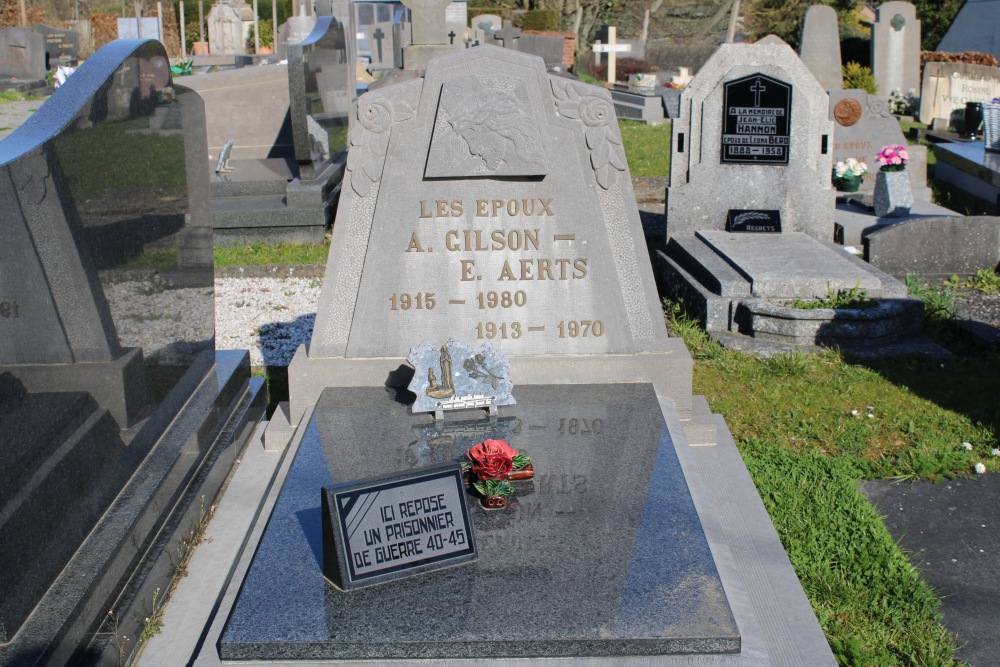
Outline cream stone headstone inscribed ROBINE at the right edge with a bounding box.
[920,62,1000,125]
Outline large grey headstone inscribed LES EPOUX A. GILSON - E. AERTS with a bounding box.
[289,46,680,422]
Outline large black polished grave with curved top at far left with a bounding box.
[0,35,264,665]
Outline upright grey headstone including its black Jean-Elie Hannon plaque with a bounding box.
[666,44,836,239]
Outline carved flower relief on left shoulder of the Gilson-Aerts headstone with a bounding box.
[347,97,413,197]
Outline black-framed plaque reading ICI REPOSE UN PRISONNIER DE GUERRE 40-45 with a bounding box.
[323,463,478,590]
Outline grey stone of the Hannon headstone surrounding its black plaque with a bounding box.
[667,44,836,239]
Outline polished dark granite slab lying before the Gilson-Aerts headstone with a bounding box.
[219,384,740,661]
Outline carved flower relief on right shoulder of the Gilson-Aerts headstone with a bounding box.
[552,79,626,190]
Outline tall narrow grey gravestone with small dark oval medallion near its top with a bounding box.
[871,0,920,99]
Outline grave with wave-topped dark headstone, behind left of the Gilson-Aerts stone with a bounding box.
[190,11,356,245]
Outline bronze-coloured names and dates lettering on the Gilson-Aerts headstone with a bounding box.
[389,197,607,340]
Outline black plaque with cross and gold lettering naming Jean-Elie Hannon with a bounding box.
[722,74,792,164]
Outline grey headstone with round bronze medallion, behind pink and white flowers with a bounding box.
[830,90,931,201]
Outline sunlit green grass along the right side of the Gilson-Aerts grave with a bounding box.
[666,300,1000,665]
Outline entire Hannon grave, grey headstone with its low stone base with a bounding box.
[658,44,922,352]
